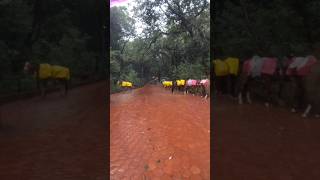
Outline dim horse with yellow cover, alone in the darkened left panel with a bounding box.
[23,62,70,97]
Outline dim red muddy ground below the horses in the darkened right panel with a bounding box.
[211,97,320,180]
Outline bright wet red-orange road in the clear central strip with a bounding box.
[110,85,210,180]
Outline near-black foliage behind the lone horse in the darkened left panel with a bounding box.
[0,0,107,93]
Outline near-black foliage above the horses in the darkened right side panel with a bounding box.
[213,0,320,58]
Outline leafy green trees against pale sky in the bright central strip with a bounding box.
[110,0,210,92]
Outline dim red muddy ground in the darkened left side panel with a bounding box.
[0,82,108,180]
